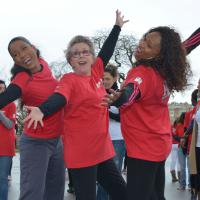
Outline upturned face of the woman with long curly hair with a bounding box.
[134,32,161,61]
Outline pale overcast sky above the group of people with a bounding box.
[0,0,200,102]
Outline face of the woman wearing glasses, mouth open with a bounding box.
[69,42,94,76]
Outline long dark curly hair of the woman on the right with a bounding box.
[135,26,192,92]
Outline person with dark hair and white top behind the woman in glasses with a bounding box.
[97,64,126,200]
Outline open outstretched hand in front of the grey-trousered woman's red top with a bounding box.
[24,106,44,129]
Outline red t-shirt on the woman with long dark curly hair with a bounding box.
[121,66,172,161]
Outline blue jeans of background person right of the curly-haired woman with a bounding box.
[178,148,190,188]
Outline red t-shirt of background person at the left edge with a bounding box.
[0,103,16,156]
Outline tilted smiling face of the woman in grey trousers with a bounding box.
[9,40,41,73]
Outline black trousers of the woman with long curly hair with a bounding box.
[127,157,165,200]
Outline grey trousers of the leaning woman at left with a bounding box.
[19,134,65,200]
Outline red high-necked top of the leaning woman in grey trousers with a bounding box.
[12,58,63,139]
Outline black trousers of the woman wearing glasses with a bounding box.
[70,159,127,200]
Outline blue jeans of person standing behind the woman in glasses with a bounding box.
[97,140,126,200]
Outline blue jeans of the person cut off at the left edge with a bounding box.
[0,156,12,200]
